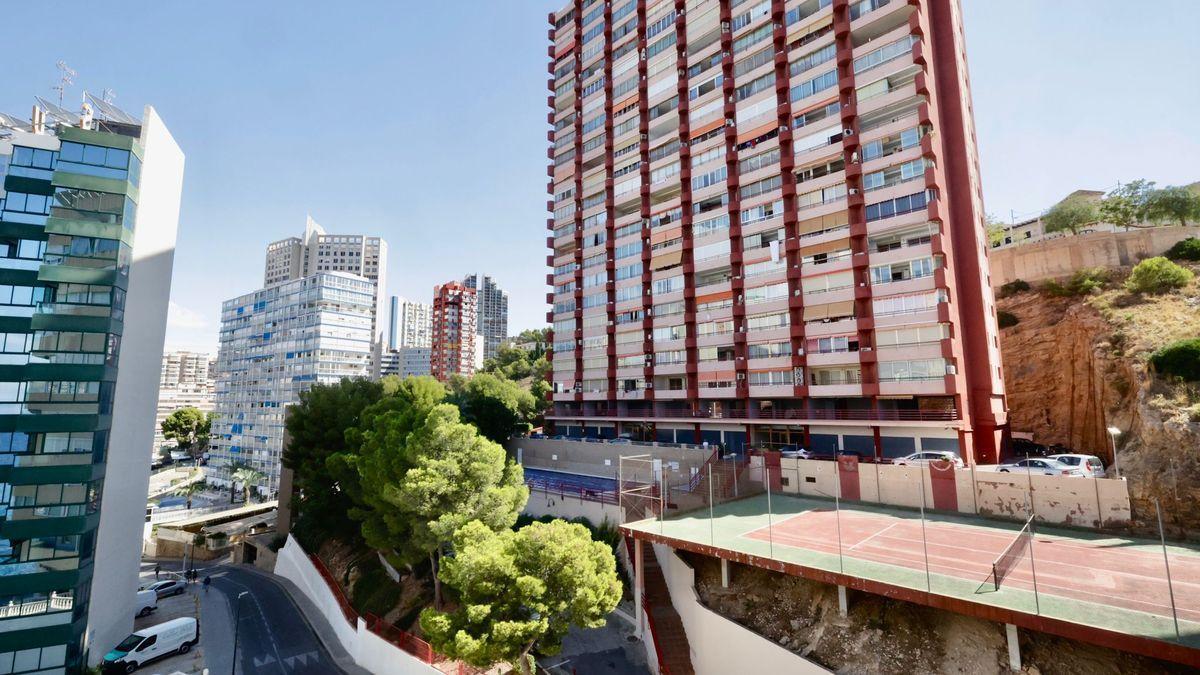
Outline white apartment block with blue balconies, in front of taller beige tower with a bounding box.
[205,271,377,495]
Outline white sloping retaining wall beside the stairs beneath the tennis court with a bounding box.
[647,544,829,675]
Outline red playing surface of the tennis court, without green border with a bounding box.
[743,509,1200,621]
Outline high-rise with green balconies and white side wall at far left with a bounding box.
[0,97,184,674]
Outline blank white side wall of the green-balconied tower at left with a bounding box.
[86,106,184,664]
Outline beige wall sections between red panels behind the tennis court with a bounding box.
[763,456,1130,527]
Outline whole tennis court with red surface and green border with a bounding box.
[625,495,1200,647]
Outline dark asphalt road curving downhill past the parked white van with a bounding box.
[207,566,342,675]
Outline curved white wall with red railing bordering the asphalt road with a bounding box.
[275,536,442,675]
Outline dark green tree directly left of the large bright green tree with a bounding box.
[282,378,379,542]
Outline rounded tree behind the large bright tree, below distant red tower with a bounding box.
[450,372,541,443]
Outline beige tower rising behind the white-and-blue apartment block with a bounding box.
[263,217,388,376]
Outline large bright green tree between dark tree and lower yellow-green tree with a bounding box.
[352,404,529,603]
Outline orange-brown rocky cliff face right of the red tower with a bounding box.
[997,276,1200,531]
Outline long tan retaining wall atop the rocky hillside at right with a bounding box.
[989,226,1200,287]
